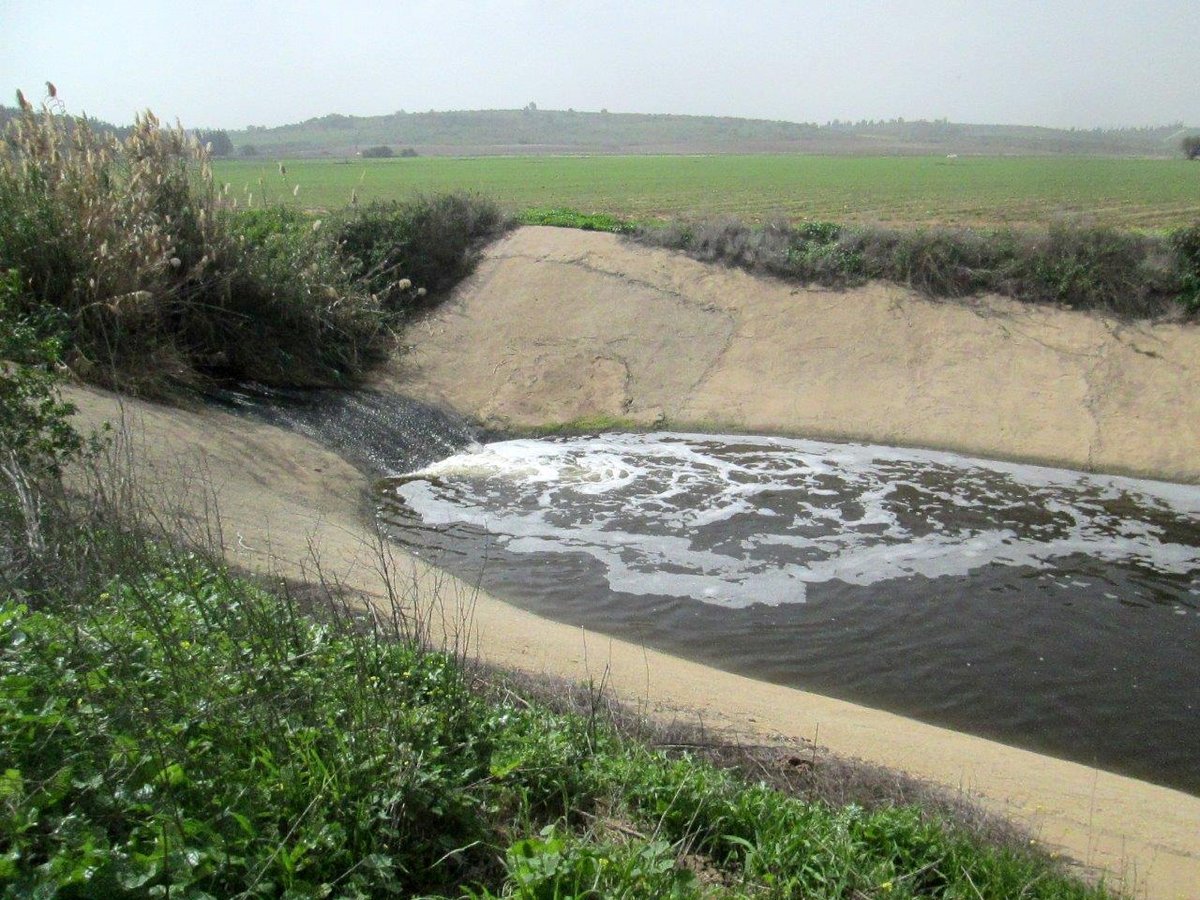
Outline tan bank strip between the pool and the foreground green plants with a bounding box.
[71,390,1200,898]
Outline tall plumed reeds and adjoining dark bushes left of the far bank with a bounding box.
[0,104,503,395]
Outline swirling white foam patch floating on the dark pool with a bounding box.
[396,433,1200,607]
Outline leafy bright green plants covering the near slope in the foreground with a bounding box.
[0,557,1105,898]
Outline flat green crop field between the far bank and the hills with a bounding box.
[215,156,1200,229]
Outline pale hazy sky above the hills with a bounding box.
[0,0,1200,127]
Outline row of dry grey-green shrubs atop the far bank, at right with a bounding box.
[632,220,1200,318]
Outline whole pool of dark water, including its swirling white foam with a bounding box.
[380,434,1200,793]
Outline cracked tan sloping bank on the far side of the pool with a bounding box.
[384,228,1200,481]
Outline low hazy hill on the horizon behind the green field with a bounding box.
[229,108,1186,157]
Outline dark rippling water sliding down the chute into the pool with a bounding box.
[212,384,478,476]
